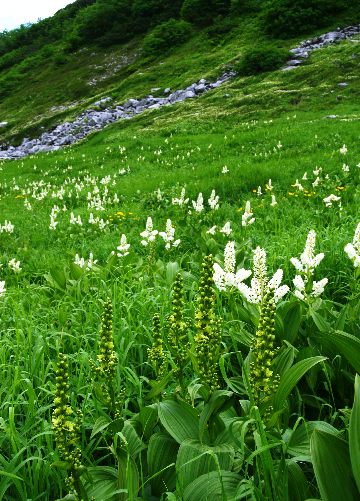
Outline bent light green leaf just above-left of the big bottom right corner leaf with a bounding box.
[284,421,339,461]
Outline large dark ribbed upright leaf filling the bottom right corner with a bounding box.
[310,430,359,501]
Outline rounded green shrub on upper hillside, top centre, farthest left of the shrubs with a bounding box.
[143,19,192,56]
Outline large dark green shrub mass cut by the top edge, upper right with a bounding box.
[263,0,350,38]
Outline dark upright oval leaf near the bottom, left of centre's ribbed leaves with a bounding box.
[147,433,179,496]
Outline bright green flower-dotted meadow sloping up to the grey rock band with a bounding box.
[0,29,360,501]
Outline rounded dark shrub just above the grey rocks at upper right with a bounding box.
[234,46,289,76]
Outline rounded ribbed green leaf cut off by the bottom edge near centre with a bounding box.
[183,471,241,501]
